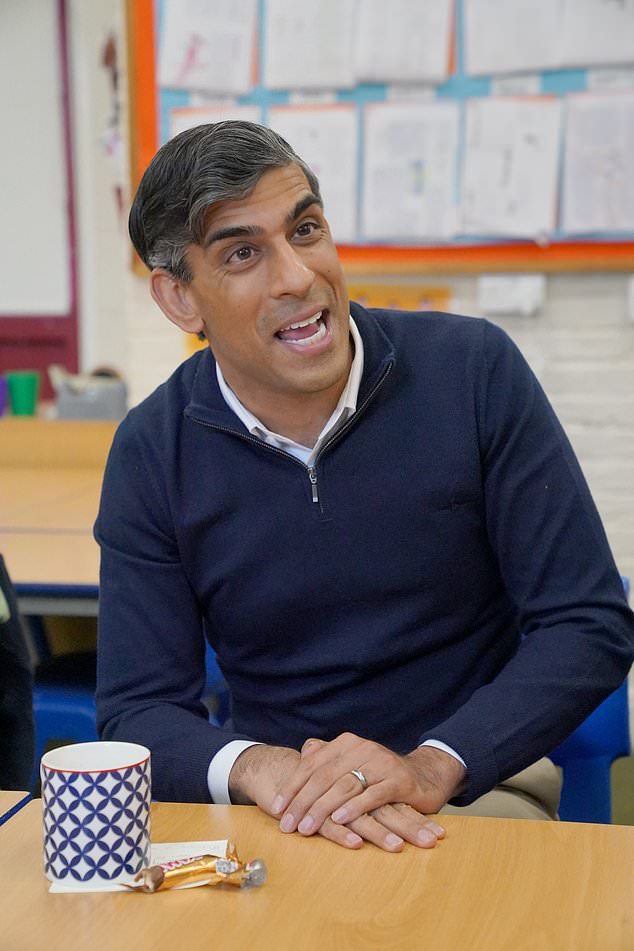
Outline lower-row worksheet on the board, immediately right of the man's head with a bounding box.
[268,105,357,242]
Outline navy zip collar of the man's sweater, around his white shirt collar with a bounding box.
[184,301,395,434]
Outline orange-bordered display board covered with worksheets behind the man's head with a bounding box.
[128,0,634,274]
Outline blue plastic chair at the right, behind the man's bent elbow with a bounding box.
[550,578,631,822]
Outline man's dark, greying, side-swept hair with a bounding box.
[128,120,321,282]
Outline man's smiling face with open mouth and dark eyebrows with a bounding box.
[187,165,351,415]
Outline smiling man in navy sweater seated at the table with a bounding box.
[96,122,634,851]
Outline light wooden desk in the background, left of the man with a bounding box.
[0,418,117,616]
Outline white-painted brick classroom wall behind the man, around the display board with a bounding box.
[69,0,634,579]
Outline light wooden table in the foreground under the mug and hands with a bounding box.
[0,801,634,951]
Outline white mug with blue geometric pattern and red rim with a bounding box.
[40,742,151,886]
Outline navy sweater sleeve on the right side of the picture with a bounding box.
[419,322,634,805]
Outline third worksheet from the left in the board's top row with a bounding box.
[355,0,453,83]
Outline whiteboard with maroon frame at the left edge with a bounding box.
[0,0,78,388]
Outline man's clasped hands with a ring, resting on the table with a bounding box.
[232,733,465,852]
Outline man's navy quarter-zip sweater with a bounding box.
[95,304,634,805]
